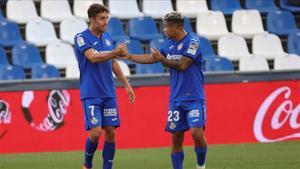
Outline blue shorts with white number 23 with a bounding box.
[166,100,206,133]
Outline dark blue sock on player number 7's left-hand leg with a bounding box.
[84,138,98,168]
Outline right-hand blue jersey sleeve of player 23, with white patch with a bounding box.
[182,40,201,60]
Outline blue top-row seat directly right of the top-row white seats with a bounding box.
[210,0,242,15]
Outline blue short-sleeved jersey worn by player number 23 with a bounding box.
[160,34,205,101]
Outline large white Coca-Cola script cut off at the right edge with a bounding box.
[253,86,300,142]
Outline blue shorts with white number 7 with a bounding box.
[81,98,120,130]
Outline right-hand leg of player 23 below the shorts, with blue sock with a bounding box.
[191,127,207,169]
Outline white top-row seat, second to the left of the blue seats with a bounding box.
[143,0,173,19]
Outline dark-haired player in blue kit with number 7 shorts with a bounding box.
[74,4,135,169]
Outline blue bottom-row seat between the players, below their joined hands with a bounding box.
[136,63,164,74]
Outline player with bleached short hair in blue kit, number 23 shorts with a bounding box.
[123,12,207,169]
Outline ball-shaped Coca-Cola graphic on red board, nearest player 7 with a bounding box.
[22,90,70,131]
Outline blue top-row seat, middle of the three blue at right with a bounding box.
[245,0,278,13]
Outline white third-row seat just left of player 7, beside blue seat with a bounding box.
[46,42,77,68]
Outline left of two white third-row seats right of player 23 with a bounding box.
[218,34,250,61]
